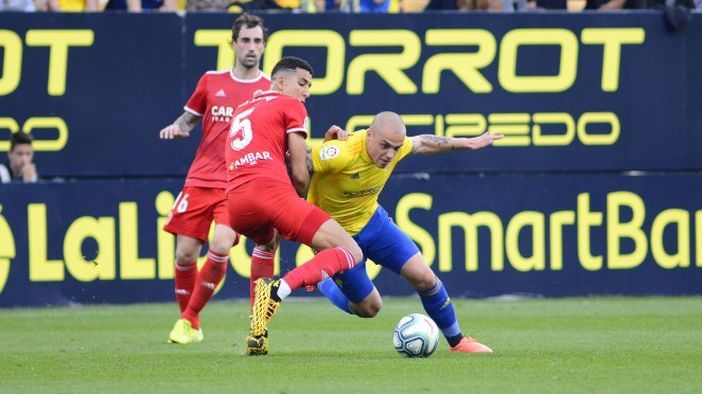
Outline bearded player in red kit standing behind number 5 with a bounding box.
[160,14,275,344]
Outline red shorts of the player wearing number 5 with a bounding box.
[227,178,331,245]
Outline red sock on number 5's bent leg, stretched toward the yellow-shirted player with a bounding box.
[283,247,355,291]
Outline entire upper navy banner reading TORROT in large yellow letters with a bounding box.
[0,12,702,178]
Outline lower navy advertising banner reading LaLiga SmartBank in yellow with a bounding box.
[0,175,702,307]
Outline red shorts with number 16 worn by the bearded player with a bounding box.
[163,186,229,243]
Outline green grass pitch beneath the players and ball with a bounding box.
[0,297,702,393]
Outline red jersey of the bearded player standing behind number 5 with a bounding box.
[185,70,271,189]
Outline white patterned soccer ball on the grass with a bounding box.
[392,313,439,357]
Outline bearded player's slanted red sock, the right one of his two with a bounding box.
[181,251,229,328]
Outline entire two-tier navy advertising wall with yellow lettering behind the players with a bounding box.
[0,12,702,306]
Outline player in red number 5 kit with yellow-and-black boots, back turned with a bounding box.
[226,57,363,355]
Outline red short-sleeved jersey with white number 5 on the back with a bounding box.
[226,91,307,190]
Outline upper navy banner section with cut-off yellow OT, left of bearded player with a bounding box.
[0,13,188,177]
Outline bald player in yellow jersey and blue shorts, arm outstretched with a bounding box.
[308,112,502,353]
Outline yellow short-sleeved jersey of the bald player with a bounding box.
[307,130,413,235]
